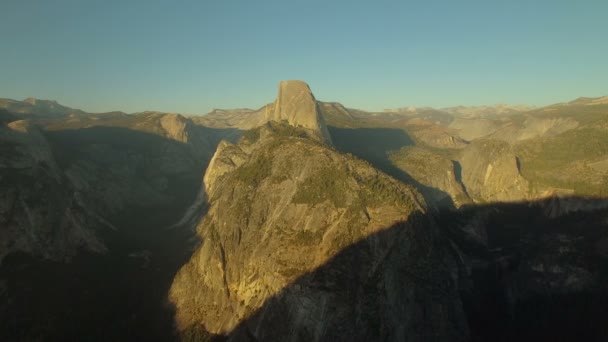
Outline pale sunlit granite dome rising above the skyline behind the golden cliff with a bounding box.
[266,80,331,144]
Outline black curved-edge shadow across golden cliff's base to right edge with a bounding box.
[182,197,608,341]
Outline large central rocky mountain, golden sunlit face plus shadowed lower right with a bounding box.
[170,122,466,341]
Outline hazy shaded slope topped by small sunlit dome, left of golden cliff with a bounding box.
[46,112,219,220]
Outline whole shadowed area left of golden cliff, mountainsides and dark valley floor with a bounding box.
[0,122,238,341]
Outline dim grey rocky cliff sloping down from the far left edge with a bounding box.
[0,120,111,261]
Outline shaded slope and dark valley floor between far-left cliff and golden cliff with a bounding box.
[0,122,238,341]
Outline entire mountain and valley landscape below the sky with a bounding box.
[0,81,608,341]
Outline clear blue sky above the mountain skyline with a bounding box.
[0,0,608,114]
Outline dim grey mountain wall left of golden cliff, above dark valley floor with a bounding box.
[0,113,227,260]
